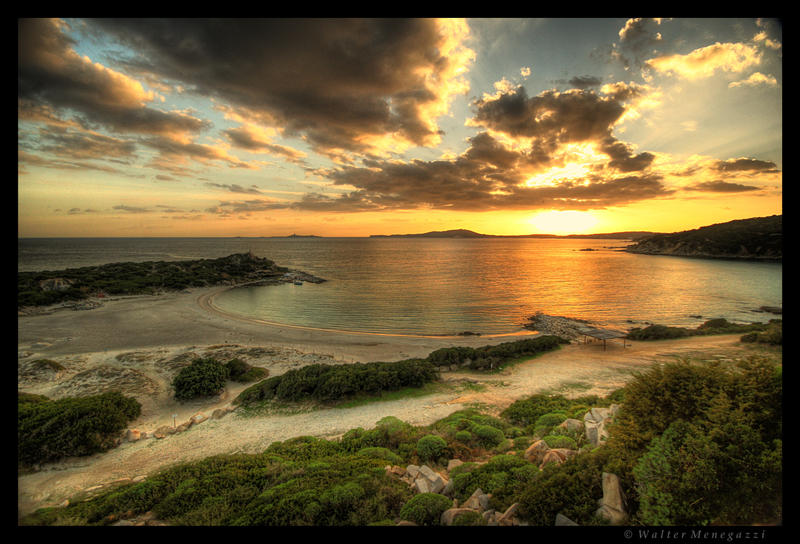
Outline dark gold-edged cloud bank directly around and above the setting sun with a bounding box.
[286,86,671,211]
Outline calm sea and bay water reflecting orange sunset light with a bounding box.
[18,238,783,334]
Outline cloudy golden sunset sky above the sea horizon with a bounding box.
[17,18,783,237]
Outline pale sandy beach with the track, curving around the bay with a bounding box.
[18,288,764,514]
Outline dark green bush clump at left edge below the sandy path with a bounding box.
[17,392,141,467]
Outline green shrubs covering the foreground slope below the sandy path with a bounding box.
[20,348,782,526]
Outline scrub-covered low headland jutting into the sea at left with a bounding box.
[17,253,322,308]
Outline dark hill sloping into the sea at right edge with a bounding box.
[625,215,783,260]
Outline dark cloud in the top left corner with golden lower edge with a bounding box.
[18,19,209,140]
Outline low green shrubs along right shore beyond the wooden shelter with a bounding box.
[626,318,783,345]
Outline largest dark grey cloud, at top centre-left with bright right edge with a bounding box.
[88,19,468,155]
